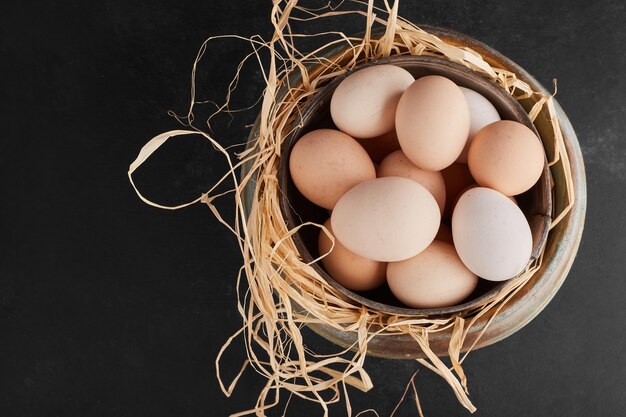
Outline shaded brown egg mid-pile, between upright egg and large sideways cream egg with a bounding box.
[376,151,446,213]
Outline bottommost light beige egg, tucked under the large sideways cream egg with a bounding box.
[387,240,478,308]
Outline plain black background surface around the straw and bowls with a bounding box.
[0,0,626,416]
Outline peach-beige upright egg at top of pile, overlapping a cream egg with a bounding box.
[396,75,470,171]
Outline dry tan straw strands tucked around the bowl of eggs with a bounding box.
[128,0,574,416]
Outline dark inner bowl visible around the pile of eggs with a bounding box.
[279,56,552,316]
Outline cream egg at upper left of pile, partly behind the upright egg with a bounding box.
[330,65,415,138]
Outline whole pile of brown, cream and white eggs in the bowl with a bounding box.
[289,65,544,308]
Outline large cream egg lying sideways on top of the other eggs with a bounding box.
[331,177,441,262]
